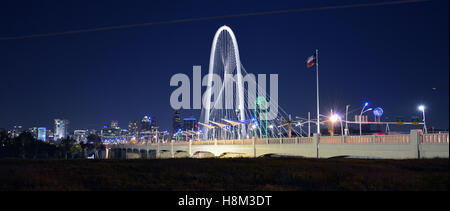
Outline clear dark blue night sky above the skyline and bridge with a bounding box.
[0,0,449,129]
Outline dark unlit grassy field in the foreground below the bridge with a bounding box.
[0,158,449,191]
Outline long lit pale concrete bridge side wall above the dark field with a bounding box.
[108,130,449,159]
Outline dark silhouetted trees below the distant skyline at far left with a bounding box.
[0,130,105,159]
